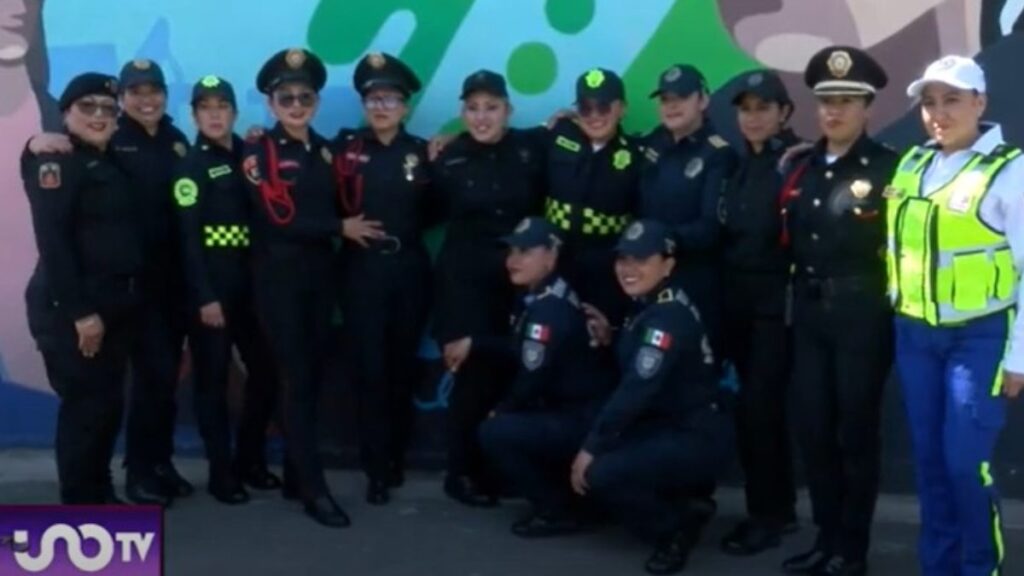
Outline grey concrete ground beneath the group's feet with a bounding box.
[0,450,1024,576]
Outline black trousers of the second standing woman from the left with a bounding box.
[125,276,187,470]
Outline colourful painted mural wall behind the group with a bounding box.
[0,0,1024,487]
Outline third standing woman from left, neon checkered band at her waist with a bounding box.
[174,76,281,504]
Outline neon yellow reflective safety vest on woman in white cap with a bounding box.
[885,145,1021,326]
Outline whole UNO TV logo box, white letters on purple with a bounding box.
[0,507,163,576]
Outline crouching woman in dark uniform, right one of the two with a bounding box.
[571,220,733,574]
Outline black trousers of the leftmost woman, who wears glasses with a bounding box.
[27,286,133,504]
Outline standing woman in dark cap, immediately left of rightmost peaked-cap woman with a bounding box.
[719,70,800,556]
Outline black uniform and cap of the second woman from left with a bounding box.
[111,60,191,503]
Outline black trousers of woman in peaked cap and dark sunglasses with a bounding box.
[255,248,337,500]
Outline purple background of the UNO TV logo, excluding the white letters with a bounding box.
[0,505,164,576]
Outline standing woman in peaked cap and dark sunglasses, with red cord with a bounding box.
[242,48,350,528]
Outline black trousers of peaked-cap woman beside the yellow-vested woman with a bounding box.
[794,277,893,560]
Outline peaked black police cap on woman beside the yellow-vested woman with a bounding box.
[804,46,889,96]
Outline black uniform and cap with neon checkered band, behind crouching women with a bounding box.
[532,69,642,326]
